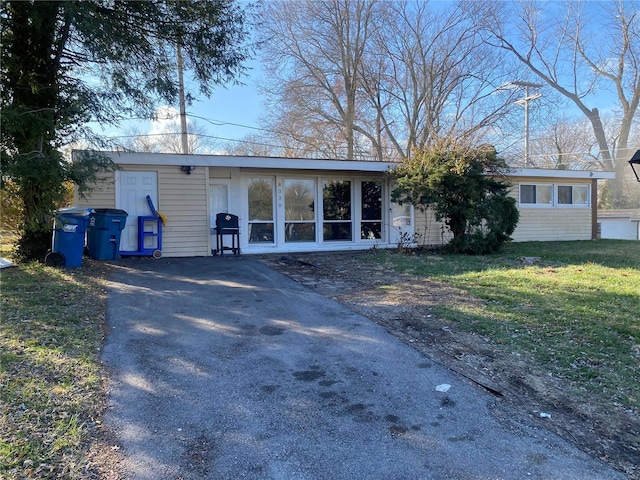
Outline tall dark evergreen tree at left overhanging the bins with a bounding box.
[0,0,248,259]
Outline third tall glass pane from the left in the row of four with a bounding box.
[322,180,353,241]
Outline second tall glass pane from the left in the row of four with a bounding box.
[284,178,316,242]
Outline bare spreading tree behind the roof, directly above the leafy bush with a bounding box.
[363,0,514,158]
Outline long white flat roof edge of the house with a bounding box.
[89,152,615,179]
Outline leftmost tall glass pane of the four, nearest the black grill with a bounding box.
[248,177,274,243]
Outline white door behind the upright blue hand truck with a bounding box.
[116,171,159,252]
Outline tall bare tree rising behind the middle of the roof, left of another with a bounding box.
[262,0,377,159]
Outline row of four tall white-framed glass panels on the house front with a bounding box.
[243,171,392,252]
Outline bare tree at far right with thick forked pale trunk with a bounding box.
[487,0,640,204]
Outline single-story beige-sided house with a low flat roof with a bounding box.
[75,152,614,257]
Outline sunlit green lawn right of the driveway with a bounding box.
[378,240,640,411]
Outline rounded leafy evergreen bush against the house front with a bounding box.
[391,143,519,254]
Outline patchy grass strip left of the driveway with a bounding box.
[0,264,104,479]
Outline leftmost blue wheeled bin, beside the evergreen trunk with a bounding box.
[52,207,90,267]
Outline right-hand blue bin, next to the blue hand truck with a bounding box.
[87,208,127,260]
